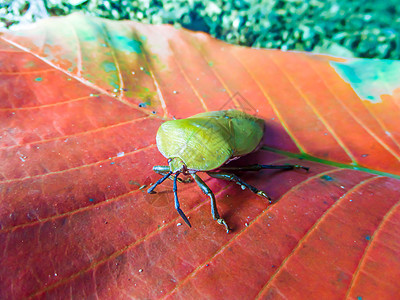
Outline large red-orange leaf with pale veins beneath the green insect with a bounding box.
[0,15,400,299]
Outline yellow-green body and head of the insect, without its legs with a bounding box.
[157,109,264,172]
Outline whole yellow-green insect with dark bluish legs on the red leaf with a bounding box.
[147,109,308,233]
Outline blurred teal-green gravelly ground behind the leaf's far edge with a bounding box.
[0,0,400,59]
